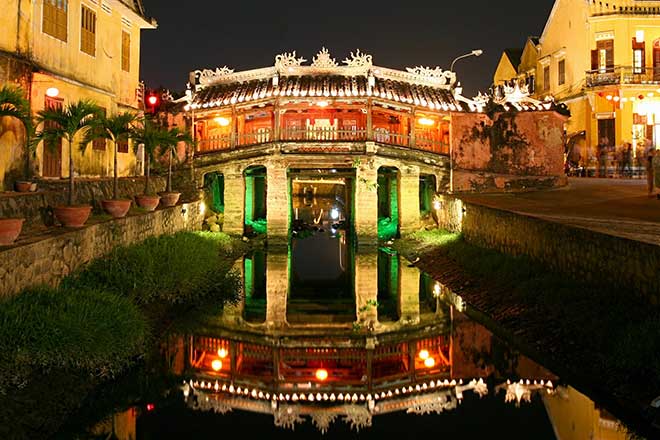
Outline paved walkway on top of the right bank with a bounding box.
[459,178,660,246]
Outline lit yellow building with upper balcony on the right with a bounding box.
[494,0,660,172]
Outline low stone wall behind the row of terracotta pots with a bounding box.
[0,177,165,228]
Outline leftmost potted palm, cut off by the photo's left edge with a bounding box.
[0,85,36,192]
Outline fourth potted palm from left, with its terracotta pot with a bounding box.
[131,116,167,211]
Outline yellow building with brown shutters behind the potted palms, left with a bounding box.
[0,0,156,189]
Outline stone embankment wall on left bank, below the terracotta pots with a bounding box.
[0,202,204,297]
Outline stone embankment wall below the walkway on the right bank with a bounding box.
[438,197,660,304]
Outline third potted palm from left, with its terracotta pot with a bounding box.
[83,112,136,218]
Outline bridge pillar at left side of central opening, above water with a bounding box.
[266,160,290,243]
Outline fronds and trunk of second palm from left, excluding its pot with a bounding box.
[36,100,102,206]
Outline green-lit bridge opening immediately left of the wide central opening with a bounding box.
[243,165,268,234]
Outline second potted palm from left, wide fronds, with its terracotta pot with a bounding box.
[36,100,102,227]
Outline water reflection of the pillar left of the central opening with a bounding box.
[266,252,289,328]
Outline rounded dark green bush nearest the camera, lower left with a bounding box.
[0,287,148,389]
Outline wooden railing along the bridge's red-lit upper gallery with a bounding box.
[197,127,449,154]
